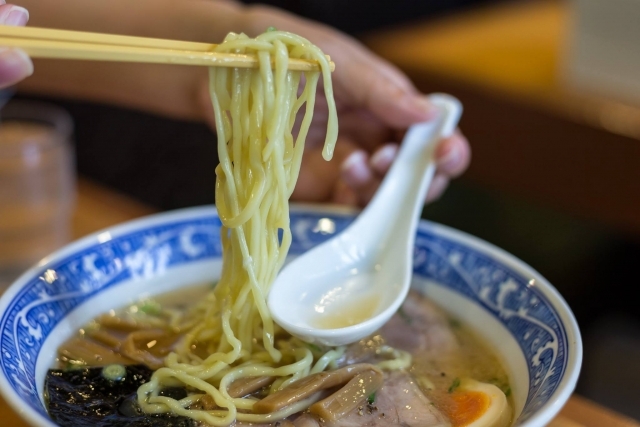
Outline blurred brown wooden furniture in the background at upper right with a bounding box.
[364,0,640,236]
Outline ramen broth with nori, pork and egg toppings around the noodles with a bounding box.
[45,284,512,427]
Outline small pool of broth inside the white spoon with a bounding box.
[313,295,380,329]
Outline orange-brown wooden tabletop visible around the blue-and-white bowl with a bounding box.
[0,179,640,427]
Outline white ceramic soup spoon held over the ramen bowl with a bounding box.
[268,94,462,345]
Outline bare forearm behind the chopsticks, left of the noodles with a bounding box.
[16,0,249,120]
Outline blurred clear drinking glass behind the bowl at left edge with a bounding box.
[0,101,75,292]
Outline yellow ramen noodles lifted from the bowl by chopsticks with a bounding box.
[138,31,344,426]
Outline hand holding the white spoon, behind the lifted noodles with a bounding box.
[240,6,471,206]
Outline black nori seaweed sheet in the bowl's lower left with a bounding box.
[45,365,195,427]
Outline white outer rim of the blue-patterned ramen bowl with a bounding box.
[0,203,583,427]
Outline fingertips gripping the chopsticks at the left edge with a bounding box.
[0,0,33,89]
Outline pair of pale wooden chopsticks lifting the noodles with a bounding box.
[0,25,335,71]
